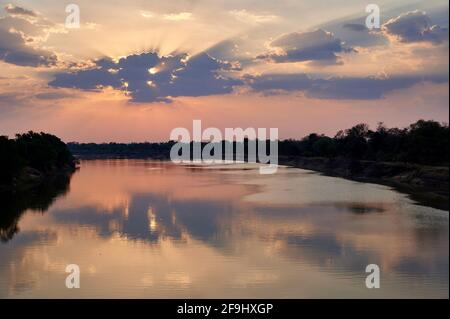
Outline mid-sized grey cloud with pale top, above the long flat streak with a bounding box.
[258,29,348,63]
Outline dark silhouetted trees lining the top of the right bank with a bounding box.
[280,120,449,165]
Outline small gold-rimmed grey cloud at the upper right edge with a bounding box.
[382,10,448,44]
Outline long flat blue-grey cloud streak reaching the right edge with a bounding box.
[247,74,448,100]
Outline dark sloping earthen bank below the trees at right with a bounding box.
[279,156,449,211]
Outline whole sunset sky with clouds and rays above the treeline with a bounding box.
[0,0,449,142]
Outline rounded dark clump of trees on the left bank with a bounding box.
[0,132,75,186]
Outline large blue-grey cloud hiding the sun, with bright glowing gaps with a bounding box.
[49,53,242,102]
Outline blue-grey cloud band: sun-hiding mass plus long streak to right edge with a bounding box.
[49,46,448,102]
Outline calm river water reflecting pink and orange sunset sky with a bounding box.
[0,160,449,298]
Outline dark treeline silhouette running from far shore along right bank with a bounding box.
[68,120,449,166]
